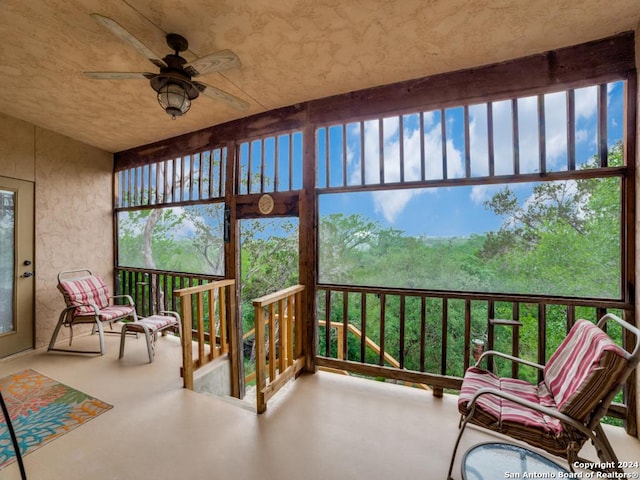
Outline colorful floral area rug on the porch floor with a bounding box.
[0,370,112,469]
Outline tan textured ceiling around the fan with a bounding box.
[0,0,640,152]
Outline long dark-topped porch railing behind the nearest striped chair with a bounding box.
[316,285,635,427]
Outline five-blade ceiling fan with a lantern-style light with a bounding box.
[84,13,249,119]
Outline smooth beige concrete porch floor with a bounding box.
[0,335,640,480]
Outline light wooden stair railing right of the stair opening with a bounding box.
[253,285,304,413]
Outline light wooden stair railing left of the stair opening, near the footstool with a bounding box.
[173,279,236,390]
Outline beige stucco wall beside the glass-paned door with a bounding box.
[0,114,113,347]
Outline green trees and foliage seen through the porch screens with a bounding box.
[119,144,622,408]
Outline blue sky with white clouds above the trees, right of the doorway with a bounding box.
[319,82,624,240]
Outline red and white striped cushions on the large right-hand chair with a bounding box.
[458,320,627,456]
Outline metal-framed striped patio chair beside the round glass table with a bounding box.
[448,314,640,478]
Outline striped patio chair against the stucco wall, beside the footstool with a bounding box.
[49,269,138,355]
